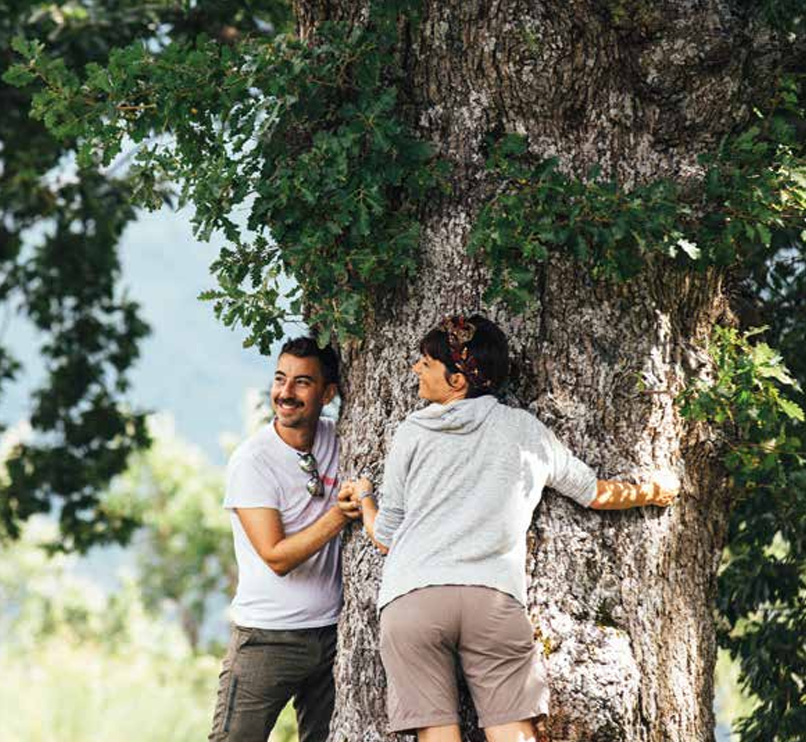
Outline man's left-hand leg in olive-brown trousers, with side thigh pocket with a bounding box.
[208,626,299,742]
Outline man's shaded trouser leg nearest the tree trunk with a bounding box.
[294,626,336,742]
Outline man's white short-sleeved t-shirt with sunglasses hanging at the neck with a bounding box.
[224,419,342,629]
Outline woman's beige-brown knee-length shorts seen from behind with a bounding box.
[381,585,549,732]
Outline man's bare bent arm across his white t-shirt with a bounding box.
[235,505,360,577]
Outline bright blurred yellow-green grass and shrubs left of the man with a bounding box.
[0,417,297,742]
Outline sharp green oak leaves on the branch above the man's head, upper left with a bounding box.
[6,5,440,353]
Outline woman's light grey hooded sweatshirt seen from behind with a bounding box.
[375,396,596,609]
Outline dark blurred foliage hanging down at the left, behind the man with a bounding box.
[0,164,148,549]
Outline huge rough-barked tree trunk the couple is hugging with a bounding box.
[297,0,784,742]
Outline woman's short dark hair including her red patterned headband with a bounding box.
[420,314,509,399]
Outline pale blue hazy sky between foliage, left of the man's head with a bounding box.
[0,203,288,464]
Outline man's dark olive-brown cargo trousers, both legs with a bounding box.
[208,626,336,742]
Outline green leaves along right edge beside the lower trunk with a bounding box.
[680,327,806,742]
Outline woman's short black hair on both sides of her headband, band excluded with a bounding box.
[420,314,509,399]
